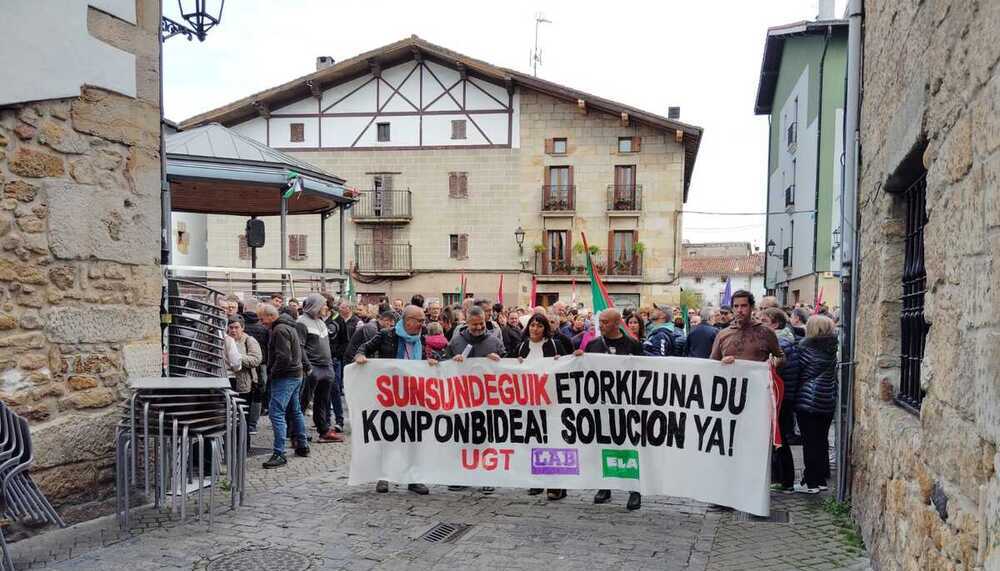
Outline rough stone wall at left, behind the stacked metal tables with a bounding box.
[0,0,161,521]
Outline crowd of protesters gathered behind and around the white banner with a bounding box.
[221,290,837,504]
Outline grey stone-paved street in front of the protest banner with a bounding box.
[5,425,868,571]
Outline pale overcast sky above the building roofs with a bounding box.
[163,0,846,249]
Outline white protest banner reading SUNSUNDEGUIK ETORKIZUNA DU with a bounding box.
[344,354,773,515]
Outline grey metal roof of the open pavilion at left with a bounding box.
[165,123,353,216]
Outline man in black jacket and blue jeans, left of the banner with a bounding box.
[257,304,309,468]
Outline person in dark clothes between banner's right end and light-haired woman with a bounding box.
[760,307,801,492]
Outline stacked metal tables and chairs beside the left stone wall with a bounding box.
[115,279,248,529]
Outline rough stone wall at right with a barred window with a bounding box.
[853,0,1000,569]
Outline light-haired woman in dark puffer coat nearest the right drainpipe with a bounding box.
[795,315,838,494]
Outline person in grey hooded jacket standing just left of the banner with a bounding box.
[296,293,344,442]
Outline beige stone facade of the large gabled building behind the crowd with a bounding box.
[201,89,684,304]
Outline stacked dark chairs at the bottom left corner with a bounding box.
[0,402,66,571]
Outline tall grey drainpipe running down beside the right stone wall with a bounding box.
[837,0,864,501]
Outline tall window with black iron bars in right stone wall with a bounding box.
[896,171,930,413]
